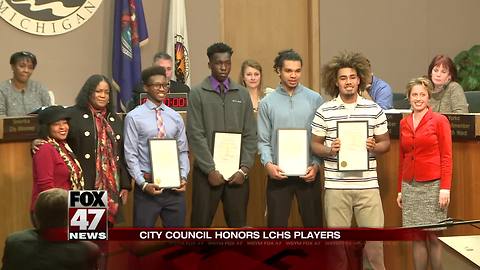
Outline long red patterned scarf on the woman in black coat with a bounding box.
[90,107,120,223]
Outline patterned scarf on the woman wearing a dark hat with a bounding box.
[47,137,85,190]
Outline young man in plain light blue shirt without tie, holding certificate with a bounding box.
[258,50,323,227]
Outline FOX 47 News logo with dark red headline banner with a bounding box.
[67,190,425,243]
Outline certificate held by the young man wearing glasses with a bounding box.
[148,138,181,188]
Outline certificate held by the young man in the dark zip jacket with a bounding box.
[213,132,242,180]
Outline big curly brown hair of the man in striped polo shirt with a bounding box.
[322,51,370,97]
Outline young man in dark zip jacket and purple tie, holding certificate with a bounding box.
[187,43,257,227]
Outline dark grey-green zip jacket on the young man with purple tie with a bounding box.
[187,77,257,174]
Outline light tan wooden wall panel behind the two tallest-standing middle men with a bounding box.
[220,0,320,93]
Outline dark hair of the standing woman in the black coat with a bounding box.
[75,74,115,112]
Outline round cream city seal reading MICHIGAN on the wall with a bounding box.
[0,0,102,36]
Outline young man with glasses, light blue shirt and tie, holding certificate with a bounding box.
[125,66,190,227]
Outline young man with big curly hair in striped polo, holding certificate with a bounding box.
[312,52,390,269]
